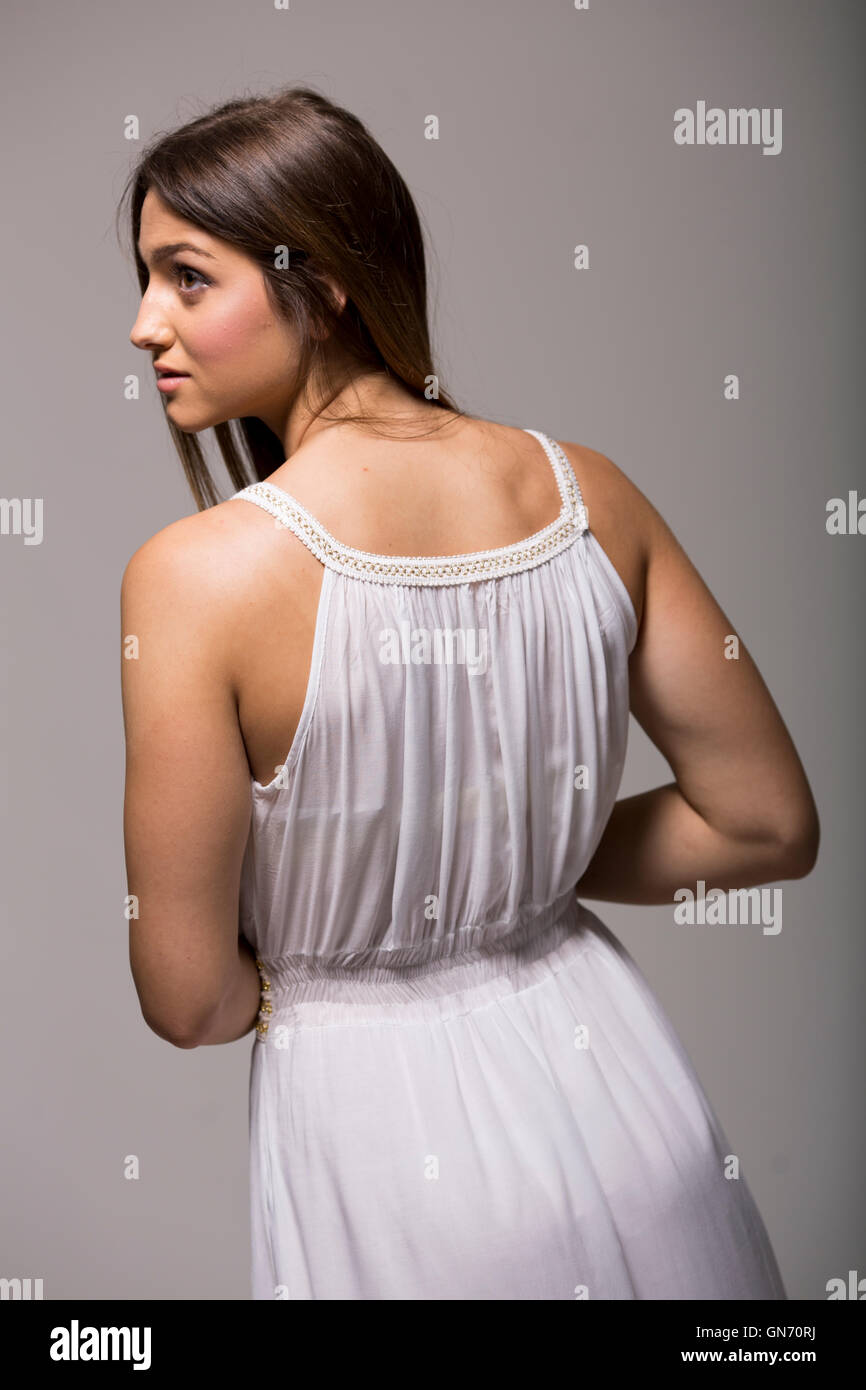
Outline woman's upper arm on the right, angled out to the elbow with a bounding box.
[628,484,819,866]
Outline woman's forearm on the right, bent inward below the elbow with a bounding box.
[575,783,799,904]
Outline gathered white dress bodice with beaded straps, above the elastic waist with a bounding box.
[230,422,637,970]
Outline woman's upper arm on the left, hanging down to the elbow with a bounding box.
[121,514,250,1041]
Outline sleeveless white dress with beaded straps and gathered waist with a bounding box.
[235,430,787,1300]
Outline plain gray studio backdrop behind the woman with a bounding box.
[0,0,866,1298]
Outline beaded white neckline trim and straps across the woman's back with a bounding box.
[231,430,589,584]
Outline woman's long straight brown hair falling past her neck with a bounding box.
[118,86,464,510]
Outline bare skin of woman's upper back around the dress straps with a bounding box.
[220,418,645,785]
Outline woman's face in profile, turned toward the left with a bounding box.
[129,189,304,436]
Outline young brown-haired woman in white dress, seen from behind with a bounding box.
[122,89,819,1300]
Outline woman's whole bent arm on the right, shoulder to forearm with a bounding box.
[577,456,820,904]
